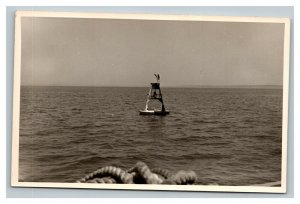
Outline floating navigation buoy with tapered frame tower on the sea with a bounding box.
[140,74,170,116]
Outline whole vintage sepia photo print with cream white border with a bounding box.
[12,11,290,193]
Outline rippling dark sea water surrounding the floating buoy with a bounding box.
[19,86,282,185]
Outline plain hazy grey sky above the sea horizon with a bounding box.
[21,17,284,87]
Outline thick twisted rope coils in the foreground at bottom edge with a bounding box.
[76,162,197,185]
